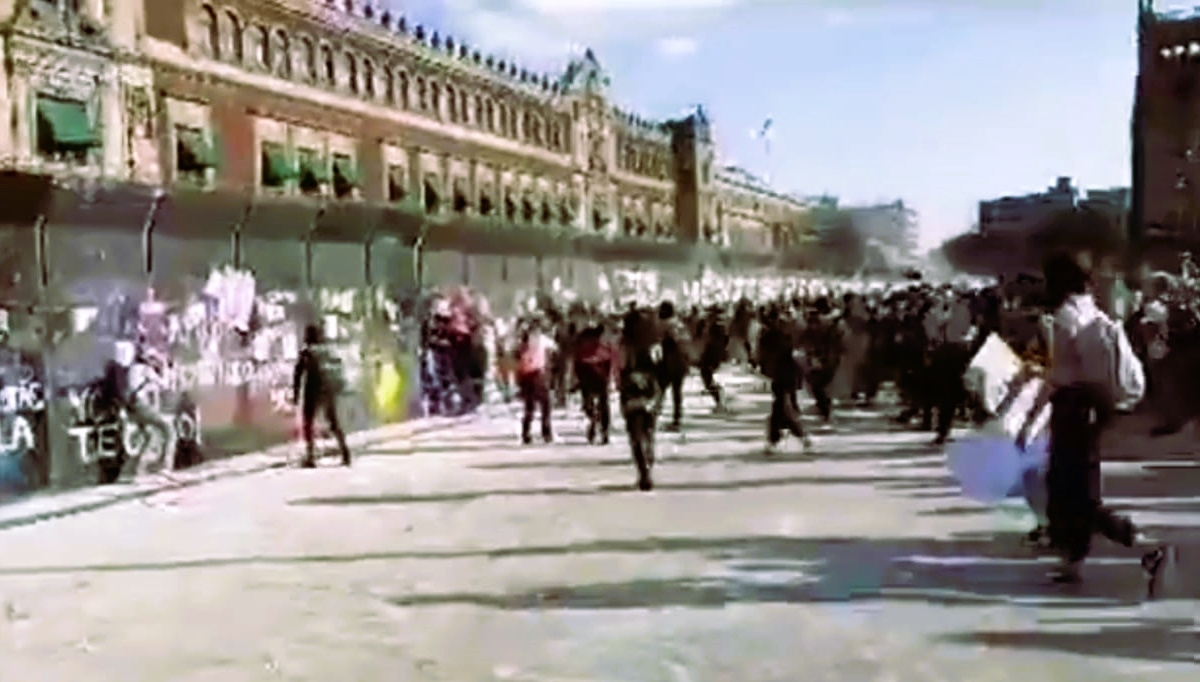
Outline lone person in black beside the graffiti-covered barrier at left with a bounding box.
[292,324,350,468]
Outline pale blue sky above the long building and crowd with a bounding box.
[392,0,1169,247]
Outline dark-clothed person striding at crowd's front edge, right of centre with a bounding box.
[758,311,812,454]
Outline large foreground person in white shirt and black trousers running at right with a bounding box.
[1016,256,1169,588]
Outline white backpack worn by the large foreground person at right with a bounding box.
[1076,312,1146,407]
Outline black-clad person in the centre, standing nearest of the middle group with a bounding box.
[618,311,662,490]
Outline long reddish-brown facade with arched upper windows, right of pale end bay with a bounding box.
[129,0,798,247]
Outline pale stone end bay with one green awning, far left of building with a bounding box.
[0,0,161,183]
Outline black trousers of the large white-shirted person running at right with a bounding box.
[1046,388,1136,563]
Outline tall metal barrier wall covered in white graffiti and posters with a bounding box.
[0,173,782,491]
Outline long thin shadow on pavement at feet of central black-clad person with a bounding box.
[288,473,946,507]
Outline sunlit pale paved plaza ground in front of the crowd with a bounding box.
[0,373,1200,682]
